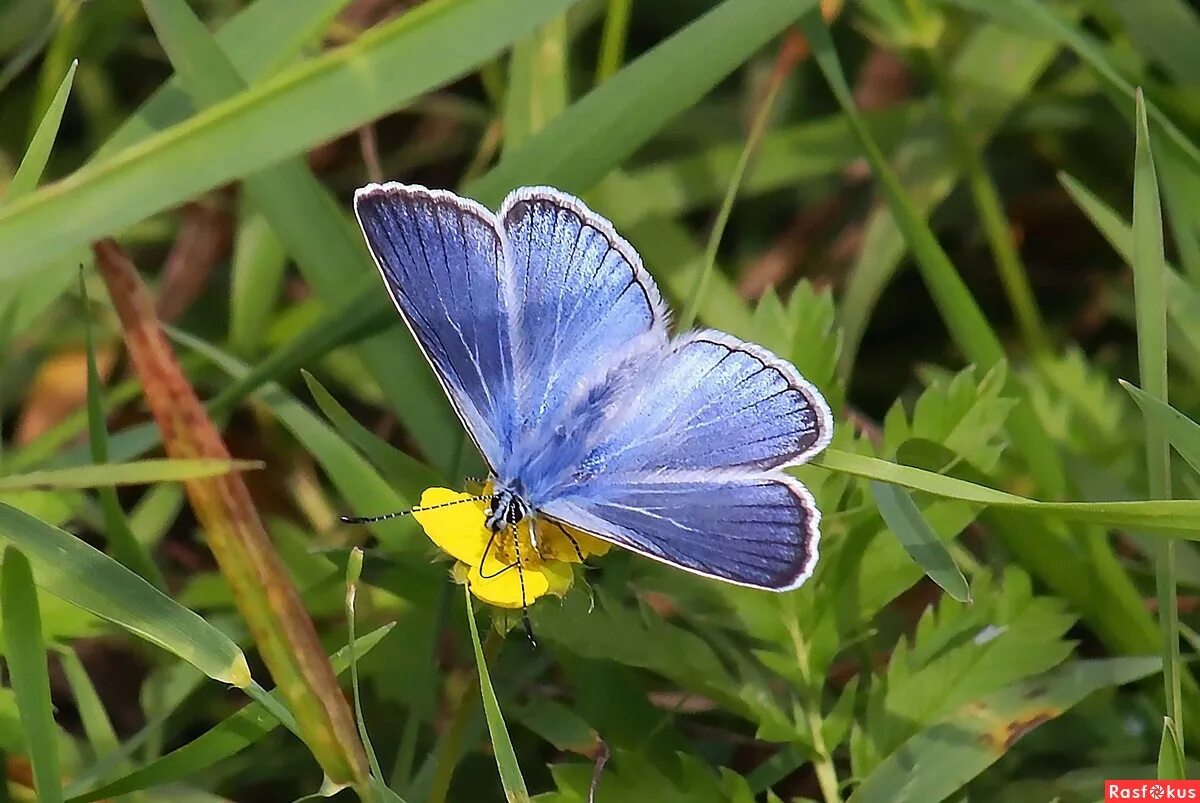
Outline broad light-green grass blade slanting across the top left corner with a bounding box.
[0,0,585,277]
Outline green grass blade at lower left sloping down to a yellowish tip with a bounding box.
[0,502,251,688]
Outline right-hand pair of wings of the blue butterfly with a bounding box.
[540,331,833,591]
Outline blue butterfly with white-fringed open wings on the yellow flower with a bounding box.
[354,182,833,591]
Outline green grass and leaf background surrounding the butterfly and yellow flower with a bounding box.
[0,0,1200,803]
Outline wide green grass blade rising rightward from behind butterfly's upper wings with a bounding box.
[465,0,816,204]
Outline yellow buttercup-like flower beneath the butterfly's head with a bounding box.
[413,487,608,607]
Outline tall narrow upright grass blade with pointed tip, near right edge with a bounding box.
[1133,91,1184,747]
